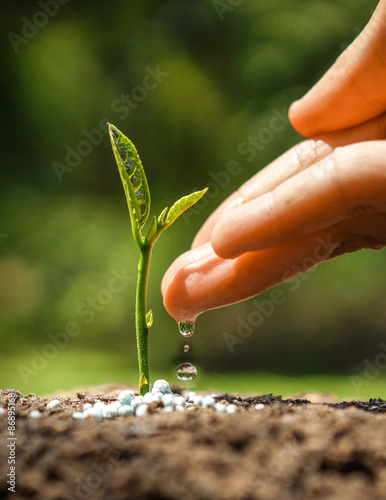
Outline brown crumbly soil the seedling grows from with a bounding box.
[0,387,386,500]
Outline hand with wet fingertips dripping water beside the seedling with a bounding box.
[162,1,386,321]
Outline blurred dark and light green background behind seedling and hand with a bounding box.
[0,0,386,398]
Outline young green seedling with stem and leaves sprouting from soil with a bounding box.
[108,123,207,395]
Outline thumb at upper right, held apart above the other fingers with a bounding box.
[289,0,386,137]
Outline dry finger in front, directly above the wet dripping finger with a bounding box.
[211,141,386,259]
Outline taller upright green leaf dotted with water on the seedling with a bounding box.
[108,123,150,229]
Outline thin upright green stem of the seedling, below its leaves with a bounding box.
[135,244,152,396]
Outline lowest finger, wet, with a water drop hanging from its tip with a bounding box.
[163,213,386,321]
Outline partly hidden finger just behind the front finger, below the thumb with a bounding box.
[192,113,386,248]
